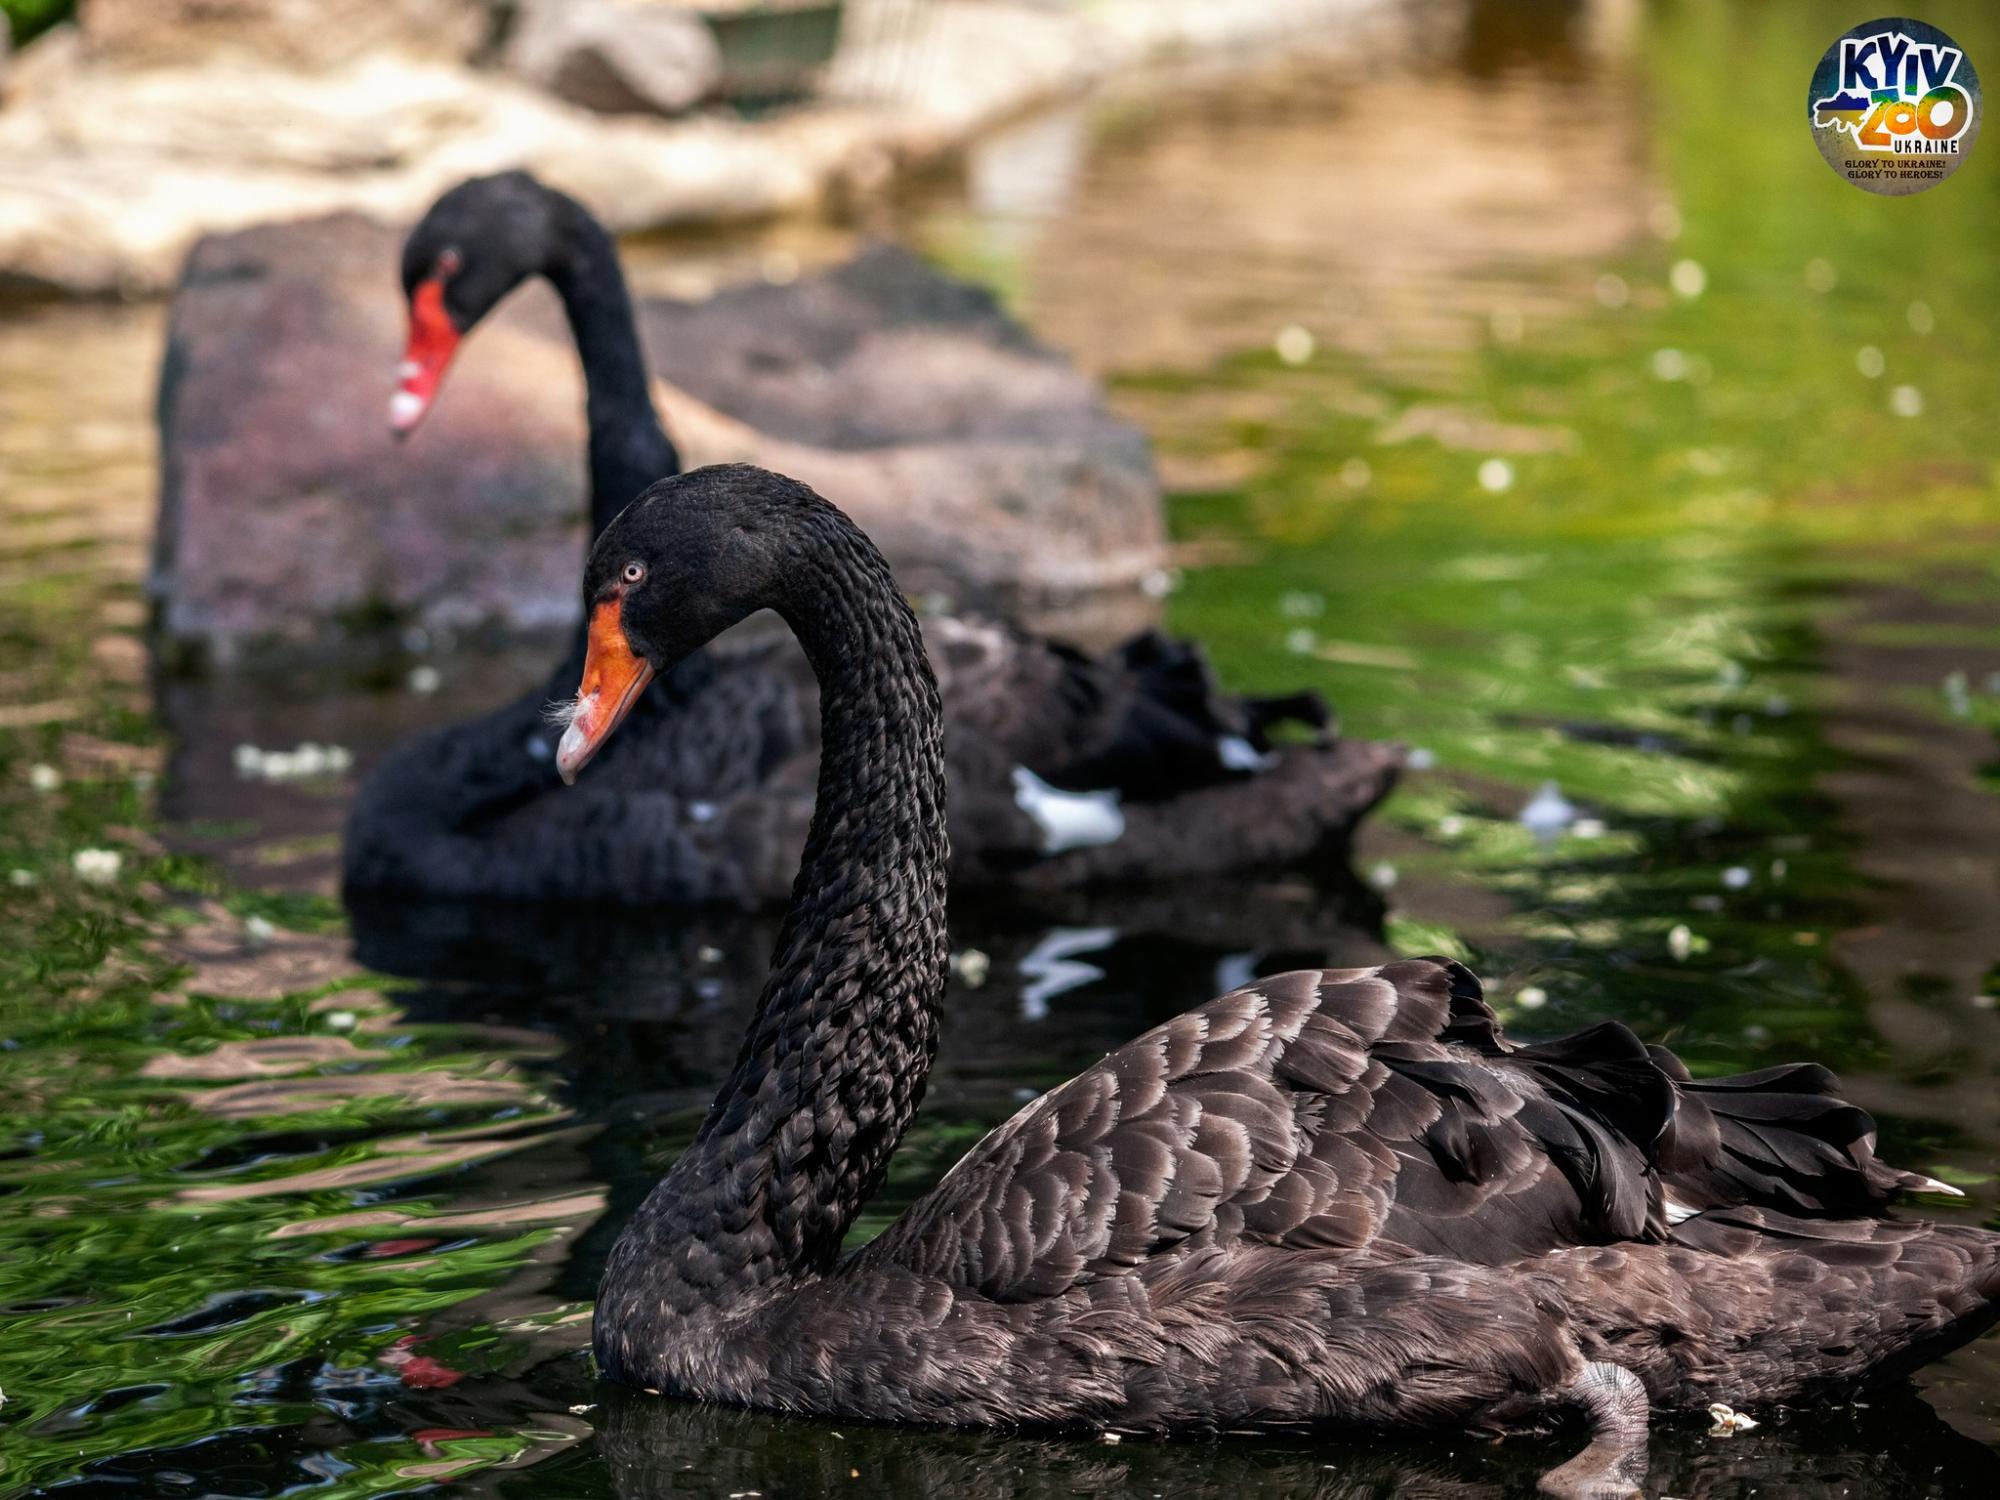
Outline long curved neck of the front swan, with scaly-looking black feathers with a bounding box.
[598,504,946,1352]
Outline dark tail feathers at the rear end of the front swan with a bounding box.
[1652,1048,1960,1222]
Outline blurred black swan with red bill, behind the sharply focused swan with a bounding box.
[344,172,1402,904]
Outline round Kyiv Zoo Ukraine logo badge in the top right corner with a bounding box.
[1806,16,1980,194]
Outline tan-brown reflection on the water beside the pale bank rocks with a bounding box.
[906,2,1656,388]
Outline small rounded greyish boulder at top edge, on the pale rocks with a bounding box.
[506,0,722,114]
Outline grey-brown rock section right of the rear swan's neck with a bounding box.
[640,246,1166,630]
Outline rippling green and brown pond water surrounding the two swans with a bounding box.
[0,0,2000,1498]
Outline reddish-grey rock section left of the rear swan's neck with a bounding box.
[150,214,584,666]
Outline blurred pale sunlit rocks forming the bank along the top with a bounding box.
[0,0,1378,294]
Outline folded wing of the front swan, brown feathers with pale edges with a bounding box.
[862,960,1672,1300]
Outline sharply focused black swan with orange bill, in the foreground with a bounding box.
[556,466,2000,1494]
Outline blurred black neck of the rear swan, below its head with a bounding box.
[544,210,680,540]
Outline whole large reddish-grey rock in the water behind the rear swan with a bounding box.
[152,214,1164,666]
